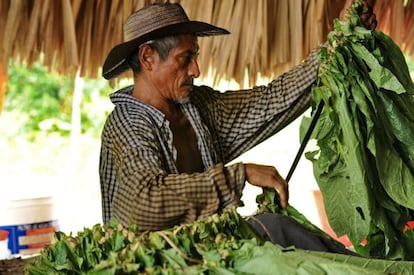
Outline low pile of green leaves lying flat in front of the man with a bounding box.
[25,202,414,275]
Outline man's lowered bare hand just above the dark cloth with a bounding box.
[244,163,289,208]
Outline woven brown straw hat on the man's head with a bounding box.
[102,3,229,79]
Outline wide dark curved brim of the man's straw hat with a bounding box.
[102,21,230,79]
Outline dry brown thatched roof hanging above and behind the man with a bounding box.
[0,0,414,110]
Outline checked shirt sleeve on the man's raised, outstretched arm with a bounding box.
[193,48,320,162]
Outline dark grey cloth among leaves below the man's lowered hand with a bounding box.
[246,213,360,256]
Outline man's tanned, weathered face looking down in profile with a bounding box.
[152,35,200,102]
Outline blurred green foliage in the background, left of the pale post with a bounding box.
[4,60,73,137]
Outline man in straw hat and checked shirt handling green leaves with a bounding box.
[100,4,378,253]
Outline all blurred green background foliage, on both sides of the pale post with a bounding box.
[4,59,112,140]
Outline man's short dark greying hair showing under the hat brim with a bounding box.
[127,36,180,75]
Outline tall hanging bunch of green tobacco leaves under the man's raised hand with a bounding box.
[301,1,414,260]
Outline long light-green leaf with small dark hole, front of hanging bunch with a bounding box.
[314,75,371,242]
